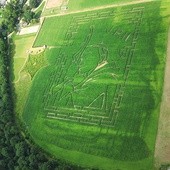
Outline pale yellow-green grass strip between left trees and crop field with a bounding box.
[12,34,35,116]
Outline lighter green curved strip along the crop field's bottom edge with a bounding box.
[32,135,152,170]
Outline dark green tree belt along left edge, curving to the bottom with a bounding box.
[0,0,84,170]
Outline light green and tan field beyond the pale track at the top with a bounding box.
[43,0,155,16]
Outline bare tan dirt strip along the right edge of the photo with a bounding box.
[155,29,170,167]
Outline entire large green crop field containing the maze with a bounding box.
[22,1,167,170]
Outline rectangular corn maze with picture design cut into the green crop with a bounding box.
[39,7,144,131]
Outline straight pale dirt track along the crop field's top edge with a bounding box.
[46,0,156,18]
